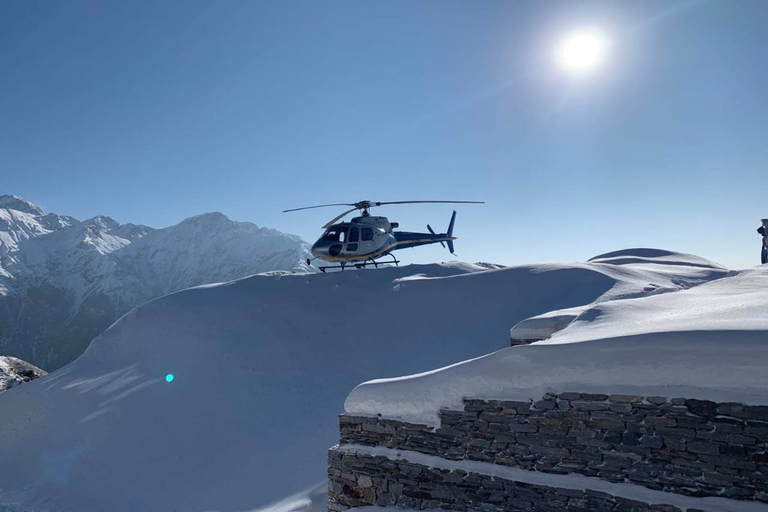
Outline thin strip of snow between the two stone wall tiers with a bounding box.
[333,445,768,512]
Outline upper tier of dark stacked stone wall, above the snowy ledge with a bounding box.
[329,393,768,510]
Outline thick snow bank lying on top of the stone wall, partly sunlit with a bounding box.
[345,262,768,425]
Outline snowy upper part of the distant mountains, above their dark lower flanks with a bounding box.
[0,196,309,308]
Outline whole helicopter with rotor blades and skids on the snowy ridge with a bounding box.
[283,201,484,272]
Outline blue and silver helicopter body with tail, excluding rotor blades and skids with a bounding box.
[312,212,456,263]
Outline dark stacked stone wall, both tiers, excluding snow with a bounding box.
[329,393,768,510]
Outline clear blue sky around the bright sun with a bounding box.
[0,0,768,268]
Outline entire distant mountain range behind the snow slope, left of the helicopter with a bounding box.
[0,195,309,371]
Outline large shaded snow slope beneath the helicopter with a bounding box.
[0,250,728,512]
